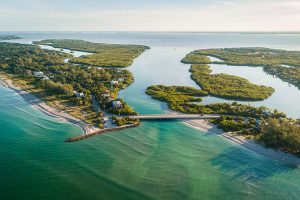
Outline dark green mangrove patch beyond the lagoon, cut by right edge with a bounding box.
[263,65,300,89]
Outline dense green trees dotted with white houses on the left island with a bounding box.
[0,43,143,127]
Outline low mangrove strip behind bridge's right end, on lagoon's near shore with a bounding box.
[146,85,285,118]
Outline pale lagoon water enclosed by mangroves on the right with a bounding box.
[202,64,300,119]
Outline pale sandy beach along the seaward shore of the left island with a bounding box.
[0,75,100,135]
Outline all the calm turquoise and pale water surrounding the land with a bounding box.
[0,33,300,200]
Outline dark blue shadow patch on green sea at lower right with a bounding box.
[210,147,296,181]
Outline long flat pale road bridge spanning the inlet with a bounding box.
[131,114,220,120]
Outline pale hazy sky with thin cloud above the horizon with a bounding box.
[0,0,300,32]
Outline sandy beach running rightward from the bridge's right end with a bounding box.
[168,108,300,167]
